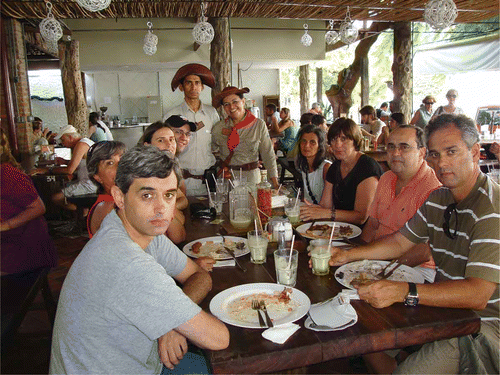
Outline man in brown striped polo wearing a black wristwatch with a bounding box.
[330,114,500,374]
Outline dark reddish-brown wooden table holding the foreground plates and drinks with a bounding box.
[182,198,480,373]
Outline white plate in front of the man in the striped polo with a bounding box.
[335,260,425,289]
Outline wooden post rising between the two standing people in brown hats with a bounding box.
[210,18,231,108]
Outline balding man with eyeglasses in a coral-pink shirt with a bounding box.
[361,125,441,282]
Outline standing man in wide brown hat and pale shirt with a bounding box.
[163,64,220,196]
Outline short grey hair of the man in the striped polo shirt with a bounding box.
[424,114,479,150]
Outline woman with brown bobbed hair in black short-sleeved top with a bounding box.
[300,118,382,225]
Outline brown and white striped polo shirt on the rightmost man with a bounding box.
[400,173,500,324]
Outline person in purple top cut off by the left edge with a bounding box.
[0,129,57,275]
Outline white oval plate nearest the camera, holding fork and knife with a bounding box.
[210,283,311,328]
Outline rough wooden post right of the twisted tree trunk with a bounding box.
[392,22,413,121]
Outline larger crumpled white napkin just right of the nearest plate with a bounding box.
[309,293,358,328]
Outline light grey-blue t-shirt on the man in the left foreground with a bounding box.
[50,211,201,374]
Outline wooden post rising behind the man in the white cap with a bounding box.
[59,40,89,136]
